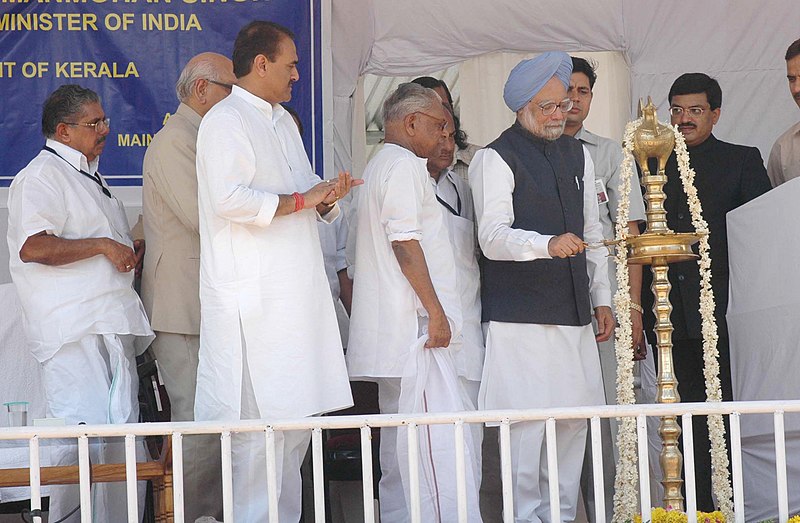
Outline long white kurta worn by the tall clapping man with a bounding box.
[195,87,352,420]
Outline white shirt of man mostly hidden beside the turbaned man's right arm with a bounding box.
[434,171,484,382]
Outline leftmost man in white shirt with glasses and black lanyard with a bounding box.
[8,85,153,521]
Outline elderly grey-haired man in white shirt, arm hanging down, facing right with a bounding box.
[347,84,461,522]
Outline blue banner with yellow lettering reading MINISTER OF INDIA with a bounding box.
[0,0,322,187]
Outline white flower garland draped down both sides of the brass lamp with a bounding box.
[613,118,733,523]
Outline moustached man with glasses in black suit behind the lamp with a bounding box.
[642,73,771,510]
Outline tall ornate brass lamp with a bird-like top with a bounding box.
[628,98,700,511]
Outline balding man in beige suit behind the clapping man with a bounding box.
[142,53,236,521]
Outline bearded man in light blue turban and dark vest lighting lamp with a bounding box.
[469,52,614,523]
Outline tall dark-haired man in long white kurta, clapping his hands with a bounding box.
[195,21,354,522]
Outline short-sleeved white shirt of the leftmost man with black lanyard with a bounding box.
[8,140,153,362]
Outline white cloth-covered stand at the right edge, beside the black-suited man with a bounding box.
[728,179,800,521]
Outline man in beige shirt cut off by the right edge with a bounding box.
[767,38,800,187]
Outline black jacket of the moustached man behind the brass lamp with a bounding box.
[642,135,772,343]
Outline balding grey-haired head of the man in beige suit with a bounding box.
[175,53,236,116]
